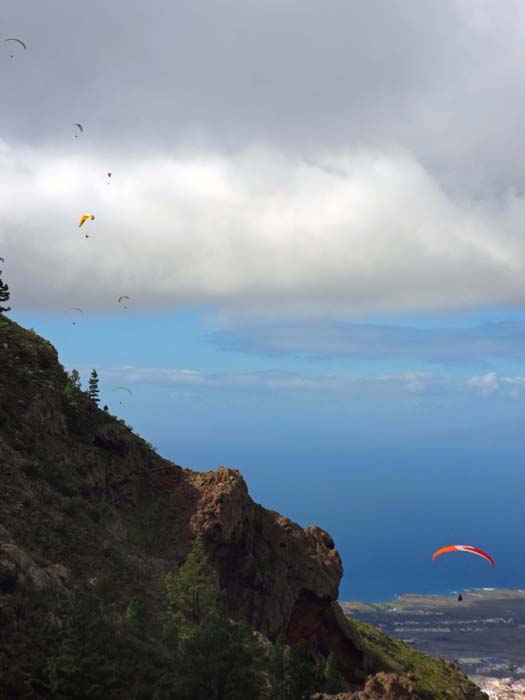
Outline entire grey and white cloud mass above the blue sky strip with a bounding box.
[5,0,525,316]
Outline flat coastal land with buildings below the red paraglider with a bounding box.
[341,589,525,699]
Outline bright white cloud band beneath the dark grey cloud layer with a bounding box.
[0,143,525,316]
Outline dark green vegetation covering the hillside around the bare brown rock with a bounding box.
[0,314,488,700]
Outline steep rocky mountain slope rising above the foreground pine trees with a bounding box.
[0,316,483,700]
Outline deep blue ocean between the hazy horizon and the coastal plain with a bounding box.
[162,438,525,602]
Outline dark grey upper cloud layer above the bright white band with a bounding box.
[4,0,525,192]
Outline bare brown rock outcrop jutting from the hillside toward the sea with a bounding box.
[149,467,365,683]
